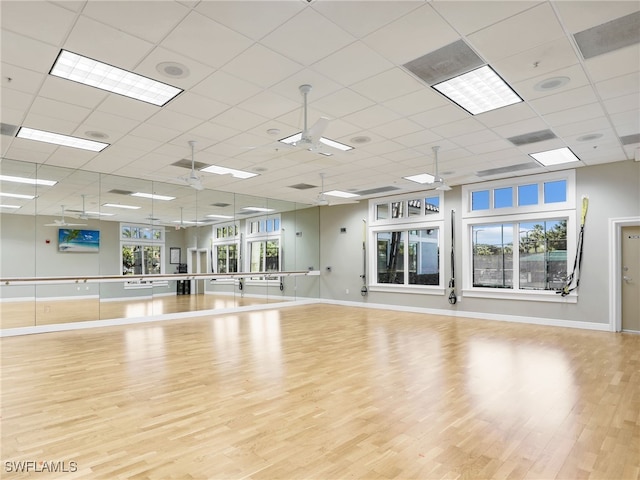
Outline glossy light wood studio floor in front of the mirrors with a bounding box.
[0,305,640,480]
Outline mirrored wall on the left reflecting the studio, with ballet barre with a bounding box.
[0,160,320,329]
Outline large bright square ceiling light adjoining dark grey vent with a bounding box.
[433,65,522,115]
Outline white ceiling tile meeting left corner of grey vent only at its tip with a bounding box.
[313,42,393,86]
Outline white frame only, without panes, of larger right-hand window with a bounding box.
[462,170,579,303]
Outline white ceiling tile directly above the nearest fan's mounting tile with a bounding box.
[262,8,355,65]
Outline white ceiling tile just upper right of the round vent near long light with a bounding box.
[162,12,253,68]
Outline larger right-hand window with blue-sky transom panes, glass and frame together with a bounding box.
[463,171,577,301]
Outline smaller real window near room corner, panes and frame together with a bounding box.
[368,192,444,293]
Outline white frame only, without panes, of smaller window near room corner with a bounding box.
[366,190,445,295]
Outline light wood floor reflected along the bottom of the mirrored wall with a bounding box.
[0,294,286,328]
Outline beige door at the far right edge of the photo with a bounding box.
[621,226,640,332]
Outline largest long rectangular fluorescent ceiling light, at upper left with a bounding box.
[49,50,182,107]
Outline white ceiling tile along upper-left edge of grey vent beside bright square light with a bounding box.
[364,4,458,64]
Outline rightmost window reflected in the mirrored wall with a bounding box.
[246,215,281,280]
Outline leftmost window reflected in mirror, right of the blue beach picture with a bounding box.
[120,224,164,275]
